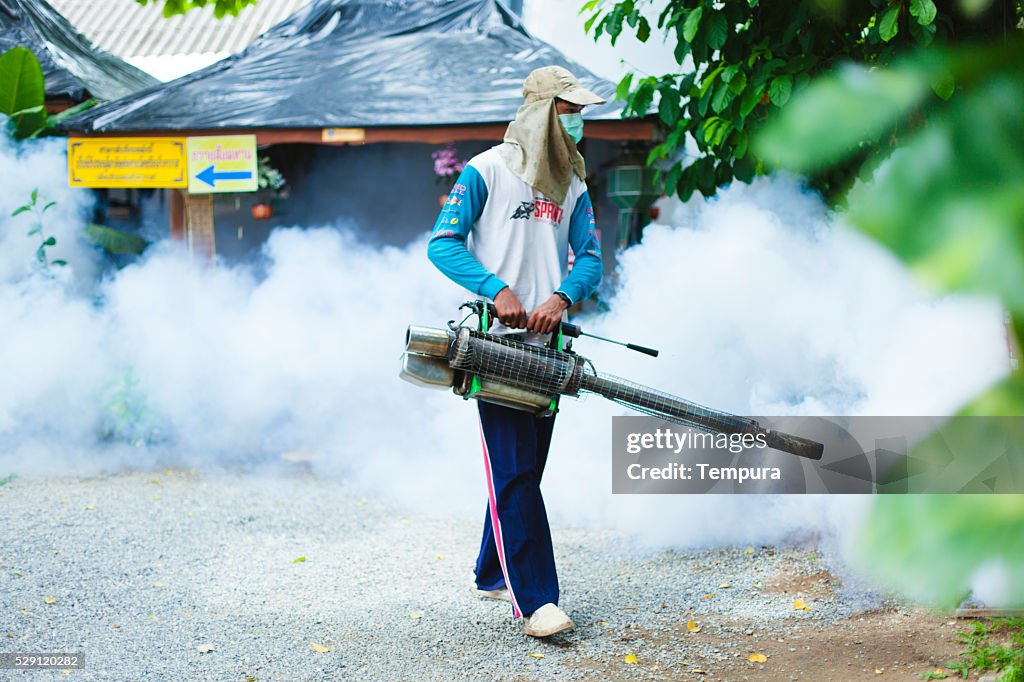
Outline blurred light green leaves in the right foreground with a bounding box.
[754,30,1024,606]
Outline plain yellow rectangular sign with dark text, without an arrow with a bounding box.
[68,137,188,188]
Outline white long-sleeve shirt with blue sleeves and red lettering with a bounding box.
[427,147,602,332]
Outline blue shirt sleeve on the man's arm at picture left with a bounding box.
[427,166,506,299]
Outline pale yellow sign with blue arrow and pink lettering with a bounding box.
[187,135,259,195]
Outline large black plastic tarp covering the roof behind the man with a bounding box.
[66,0,621,132]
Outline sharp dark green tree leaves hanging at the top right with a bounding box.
[581,0,1021,200]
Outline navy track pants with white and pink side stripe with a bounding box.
[476,401,558,619]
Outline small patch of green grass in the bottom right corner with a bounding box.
[947,617,1024,682]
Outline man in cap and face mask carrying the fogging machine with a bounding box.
[428,67,604,637]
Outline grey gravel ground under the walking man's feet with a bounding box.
[0,471,897,681]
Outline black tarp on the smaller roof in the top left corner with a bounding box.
[0,0,160,101]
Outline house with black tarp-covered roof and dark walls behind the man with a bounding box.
[67,0,654,258]
